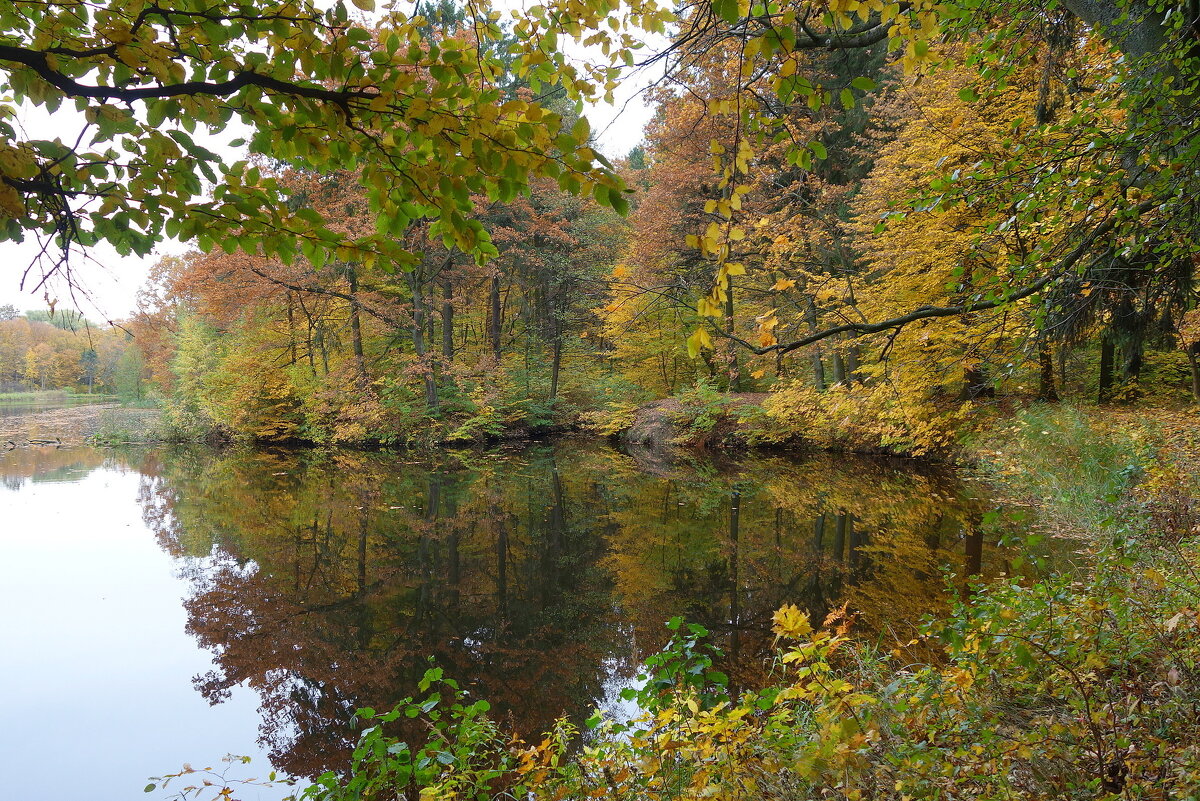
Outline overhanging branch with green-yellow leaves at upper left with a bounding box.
[0,0,632,281]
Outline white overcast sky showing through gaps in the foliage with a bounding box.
[0,43,653,323]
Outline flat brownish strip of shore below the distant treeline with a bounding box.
[0,403,161,450]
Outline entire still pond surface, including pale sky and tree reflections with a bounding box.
[0,441,1009,801]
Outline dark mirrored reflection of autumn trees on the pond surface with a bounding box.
[129,441,1007,776]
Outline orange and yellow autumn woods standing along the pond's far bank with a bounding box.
[84,6,1200,453]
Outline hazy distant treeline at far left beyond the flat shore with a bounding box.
[0,305,144,401]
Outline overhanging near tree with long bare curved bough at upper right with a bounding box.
[668,0,1200,353]
